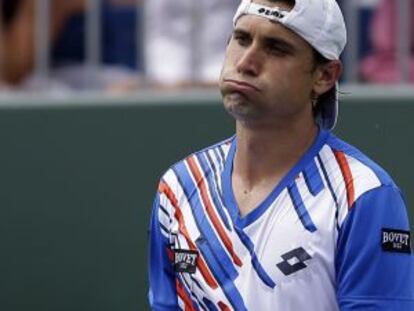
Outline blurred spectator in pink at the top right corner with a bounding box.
[360,0,414,83]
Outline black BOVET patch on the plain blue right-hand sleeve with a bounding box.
[381,228,411,254]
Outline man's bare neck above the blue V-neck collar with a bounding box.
[232,119,318,216]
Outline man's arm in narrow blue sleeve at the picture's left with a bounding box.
[148,193,178,311]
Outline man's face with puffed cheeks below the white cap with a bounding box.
[220,1,315,124]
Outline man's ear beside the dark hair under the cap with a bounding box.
[313,60,342,96]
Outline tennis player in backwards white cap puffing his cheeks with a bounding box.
[149,0,414,311]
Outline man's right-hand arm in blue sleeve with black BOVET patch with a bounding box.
[336,186,414,311]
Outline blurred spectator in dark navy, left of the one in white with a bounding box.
[52,0,144,92]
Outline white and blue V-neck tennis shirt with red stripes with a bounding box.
[149,131,414,311]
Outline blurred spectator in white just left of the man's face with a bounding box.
[145,0,240,87]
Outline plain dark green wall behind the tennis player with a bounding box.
[0,96,414,311]
